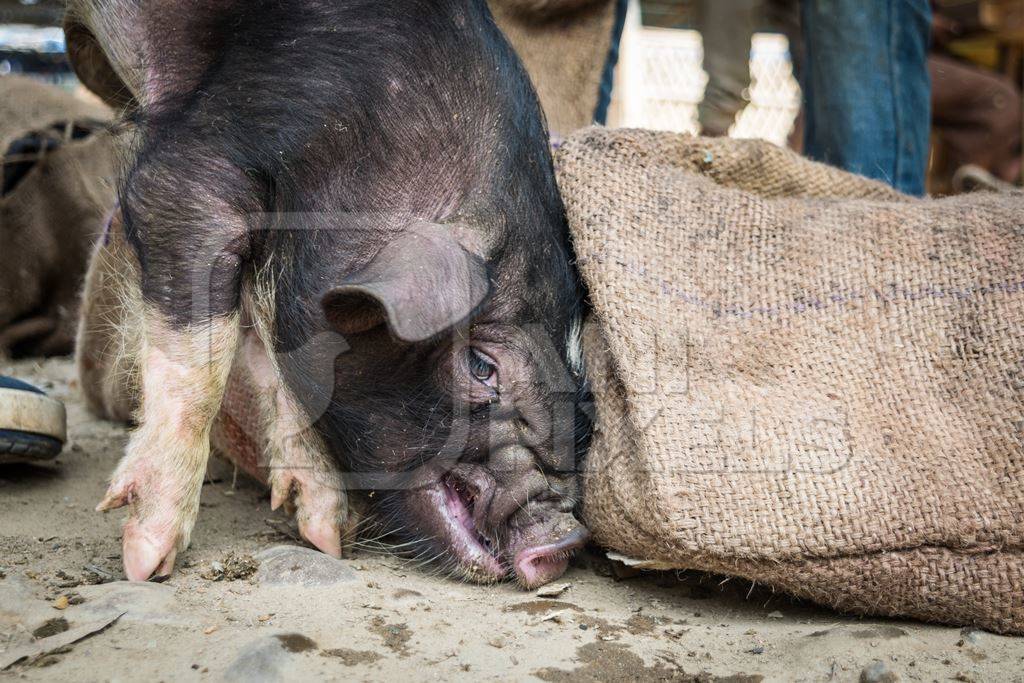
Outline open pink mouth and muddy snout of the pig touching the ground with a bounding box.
[403,472,590,589]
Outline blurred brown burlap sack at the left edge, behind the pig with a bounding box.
[0,76,115,355]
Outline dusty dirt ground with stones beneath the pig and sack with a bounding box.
[6,359,1024,681]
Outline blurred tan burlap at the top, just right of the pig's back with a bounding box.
[488,0,615,139]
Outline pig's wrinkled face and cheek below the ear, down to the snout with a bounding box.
[303,316,586,587]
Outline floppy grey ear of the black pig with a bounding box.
[322,226,490,342]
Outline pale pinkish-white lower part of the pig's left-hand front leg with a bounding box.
[97,307,239,581]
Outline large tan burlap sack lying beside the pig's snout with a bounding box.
[558,129,1024,633]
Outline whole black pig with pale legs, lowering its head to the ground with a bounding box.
[66,0,588,588]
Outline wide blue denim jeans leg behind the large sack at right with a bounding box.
[801,0,931,195]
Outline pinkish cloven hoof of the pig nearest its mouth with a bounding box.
[270,469,348,557]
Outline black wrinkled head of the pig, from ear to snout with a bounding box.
[276,211,588,587]
